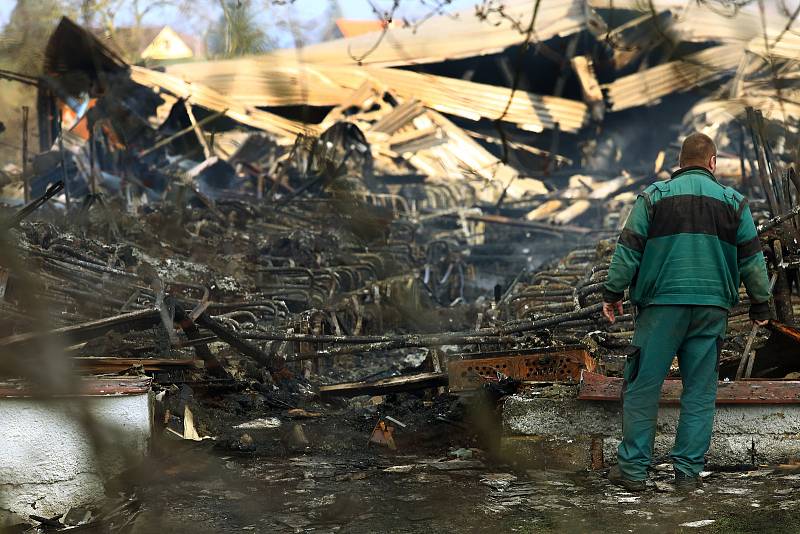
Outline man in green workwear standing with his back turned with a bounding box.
[603,133,770,491]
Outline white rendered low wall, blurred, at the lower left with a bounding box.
[0,394,152,517]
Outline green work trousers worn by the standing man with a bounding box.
[617,305,728,480]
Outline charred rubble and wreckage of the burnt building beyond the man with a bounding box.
[0,2,800,528]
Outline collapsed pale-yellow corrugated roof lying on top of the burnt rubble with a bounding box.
[34,0,800,209]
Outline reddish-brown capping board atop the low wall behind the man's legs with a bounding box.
[578,371,800,404]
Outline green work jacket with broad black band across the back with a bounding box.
[603,167,770,319]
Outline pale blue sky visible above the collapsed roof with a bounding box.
[0,0,480,46]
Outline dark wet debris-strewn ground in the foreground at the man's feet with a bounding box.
[128,448,800,534]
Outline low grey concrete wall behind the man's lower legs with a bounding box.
[503,395,800,465]
